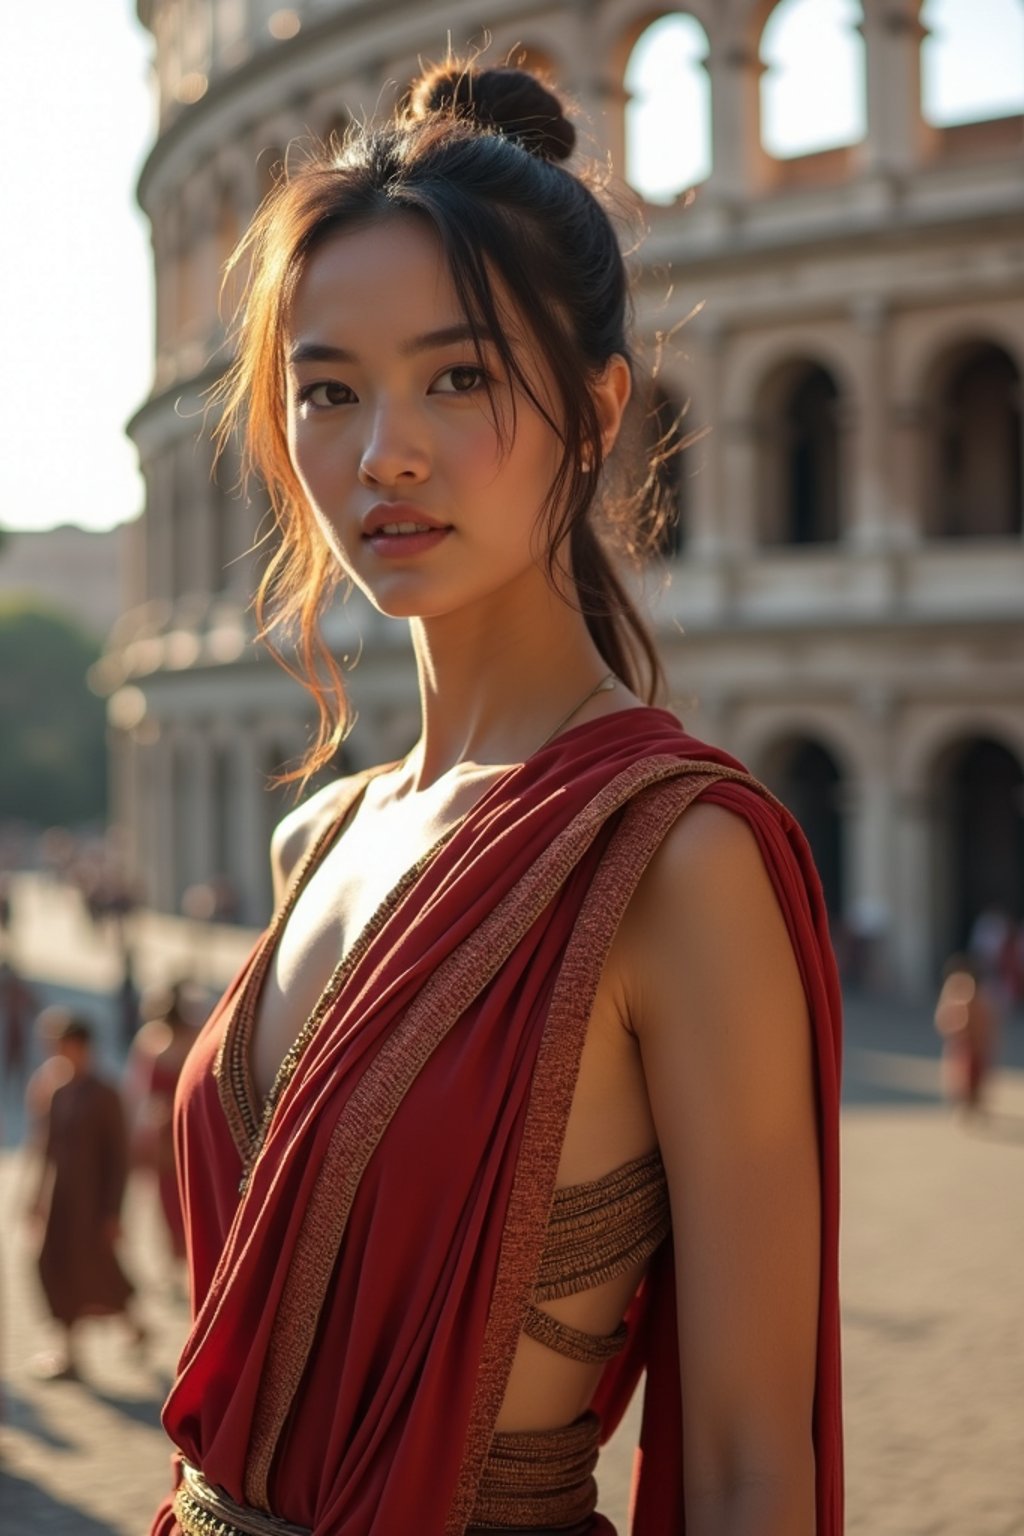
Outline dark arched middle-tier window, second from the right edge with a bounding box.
[758,361,841,544]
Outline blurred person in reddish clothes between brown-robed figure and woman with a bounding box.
[124,983,198,1261]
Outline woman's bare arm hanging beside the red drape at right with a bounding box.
[628,805,820,1528]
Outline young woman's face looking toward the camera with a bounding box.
[286,215,560,617]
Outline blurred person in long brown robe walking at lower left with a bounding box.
[29,1015,144,1378]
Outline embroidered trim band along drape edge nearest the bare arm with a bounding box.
[445,754,767,1536]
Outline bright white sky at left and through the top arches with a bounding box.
[0,0,1024,528]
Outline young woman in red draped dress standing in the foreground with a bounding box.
[154,66,841,1536]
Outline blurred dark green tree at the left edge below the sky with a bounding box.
[0,598,106,826]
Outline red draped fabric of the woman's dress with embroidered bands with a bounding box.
[152,710,841,1536]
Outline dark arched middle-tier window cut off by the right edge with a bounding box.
[930,343,1024,539]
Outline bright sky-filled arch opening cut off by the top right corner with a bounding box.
[921,0,1024,127]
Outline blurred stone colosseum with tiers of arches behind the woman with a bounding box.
[103,0,1024,997]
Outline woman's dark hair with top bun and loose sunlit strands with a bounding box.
[218,60,672,779]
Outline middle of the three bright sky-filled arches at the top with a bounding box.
[760,0,867,160]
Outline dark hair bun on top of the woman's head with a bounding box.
[408,63,576,160]
